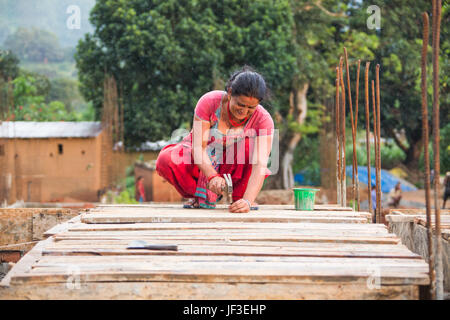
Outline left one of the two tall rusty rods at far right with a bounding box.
[421,12,436,299]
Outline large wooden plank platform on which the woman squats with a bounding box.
[0,204,429,299]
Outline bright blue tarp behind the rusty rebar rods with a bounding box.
[346,166,417,193]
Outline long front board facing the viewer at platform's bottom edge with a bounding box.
[0,279,419,300]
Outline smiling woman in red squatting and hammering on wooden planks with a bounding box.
[156,67,274,213]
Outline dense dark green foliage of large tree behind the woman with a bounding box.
[76,0,295,147]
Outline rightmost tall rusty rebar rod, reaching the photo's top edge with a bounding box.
[433,0,444,300]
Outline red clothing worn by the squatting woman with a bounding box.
[156,91,273,208]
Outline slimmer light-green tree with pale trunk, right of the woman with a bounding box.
[269,0,378,189]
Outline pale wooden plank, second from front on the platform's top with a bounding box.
[12,256,428,277]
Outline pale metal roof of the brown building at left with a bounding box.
[0,121,102,139]
